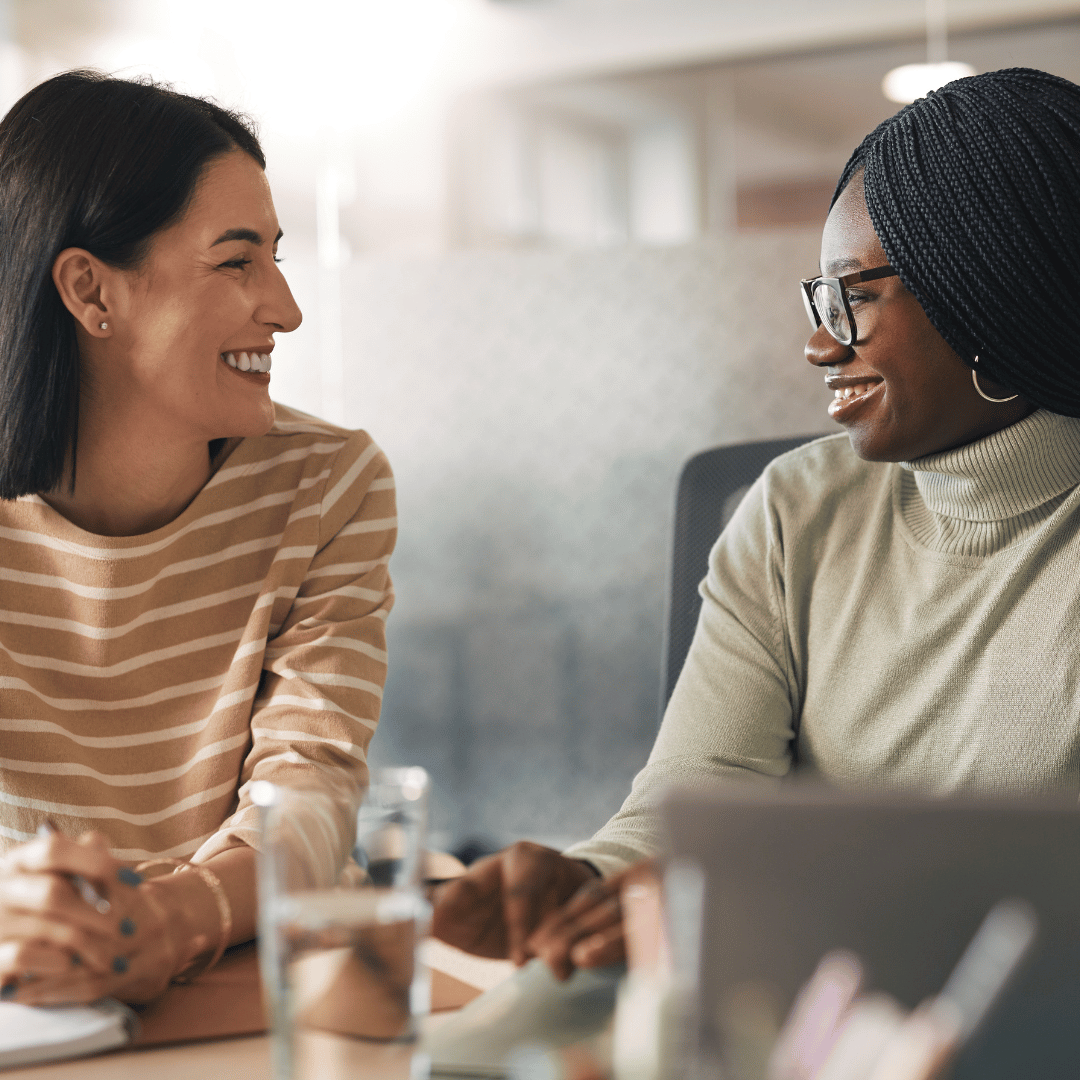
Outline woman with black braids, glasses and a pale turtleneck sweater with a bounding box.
[435,69,1080,974]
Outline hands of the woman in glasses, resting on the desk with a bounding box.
[433,840,630,978]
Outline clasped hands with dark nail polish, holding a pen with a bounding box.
[0,833,206,1004]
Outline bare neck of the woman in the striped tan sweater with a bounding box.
[42,397,212,537]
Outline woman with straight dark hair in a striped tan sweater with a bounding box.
[0,72,395,1003]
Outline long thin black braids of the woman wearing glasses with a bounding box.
[833,68,1080,416]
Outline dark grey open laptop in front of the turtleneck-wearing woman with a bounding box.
[662,785,1080,1080]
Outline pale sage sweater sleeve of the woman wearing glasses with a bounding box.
[566,473,798,877]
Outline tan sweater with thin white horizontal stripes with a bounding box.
[0,406,396,877]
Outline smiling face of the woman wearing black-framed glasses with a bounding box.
[806,176,1035,461]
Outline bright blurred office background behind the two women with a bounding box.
[8,0,1080,847]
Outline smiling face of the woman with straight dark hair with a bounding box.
[95,150,300,442]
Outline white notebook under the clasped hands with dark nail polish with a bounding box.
[0,999,138,1068]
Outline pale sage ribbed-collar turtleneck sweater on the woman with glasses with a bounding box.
[568,411,1080,874]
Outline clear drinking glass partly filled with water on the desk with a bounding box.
[252,767,430,1080]
